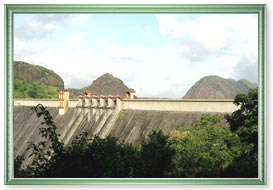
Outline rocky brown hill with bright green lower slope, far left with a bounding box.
[13,61,64,98]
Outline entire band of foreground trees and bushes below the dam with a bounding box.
[14,89,258,178]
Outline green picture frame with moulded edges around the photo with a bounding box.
[5,4,266,185]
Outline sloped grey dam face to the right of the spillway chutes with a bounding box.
[109,110,226,143]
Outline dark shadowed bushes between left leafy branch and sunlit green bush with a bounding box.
[44,132,172,178]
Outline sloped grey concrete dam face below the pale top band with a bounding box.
[13,105,228,156]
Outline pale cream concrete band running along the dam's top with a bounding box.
[14,98,239,113]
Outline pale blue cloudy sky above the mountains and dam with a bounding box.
[14,14,258,98]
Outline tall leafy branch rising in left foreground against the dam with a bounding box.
[15,104,64,177]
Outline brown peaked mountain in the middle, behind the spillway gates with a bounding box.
[68,73,129,98]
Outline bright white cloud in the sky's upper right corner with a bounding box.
[156,14,258,51]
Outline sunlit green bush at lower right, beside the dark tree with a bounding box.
[169,116,240,177]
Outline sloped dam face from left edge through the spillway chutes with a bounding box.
[13,106,120,156]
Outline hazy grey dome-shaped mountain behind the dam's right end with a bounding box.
[183,75,257,99]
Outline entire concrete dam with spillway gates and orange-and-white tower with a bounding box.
[13,90,238,156]
